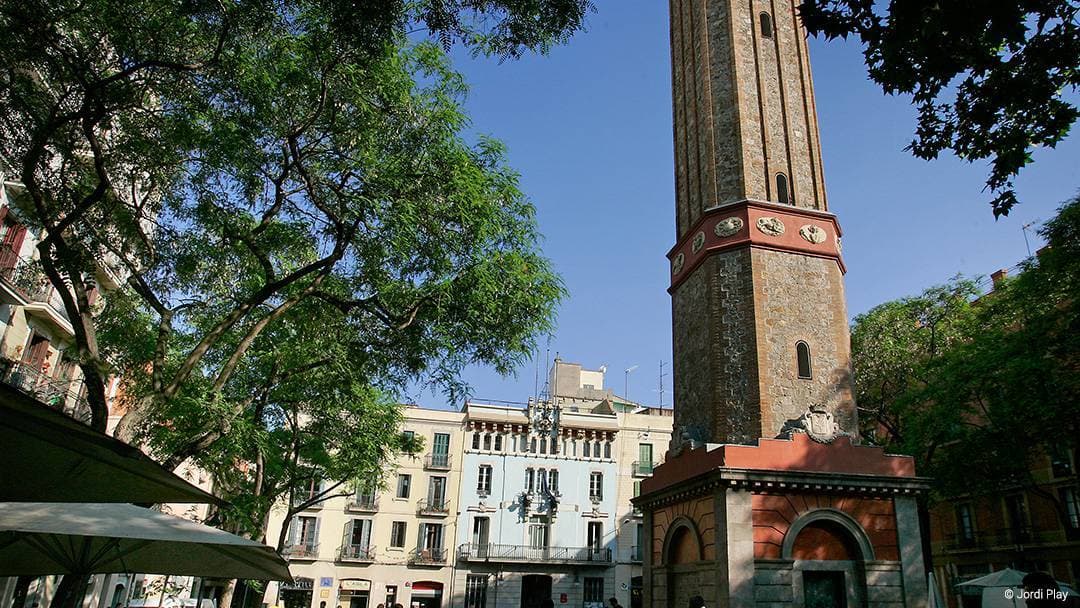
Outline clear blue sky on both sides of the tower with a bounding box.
[403,0,1080,407]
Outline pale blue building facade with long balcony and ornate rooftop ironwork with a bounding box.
[455,404,620,608]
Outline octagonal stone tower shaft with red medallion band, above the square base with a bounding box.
[669,0,856,444]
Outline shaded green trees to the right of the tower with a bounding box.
[852,198,1080,522]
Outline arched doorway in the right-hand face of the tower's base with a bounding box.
[782,509,874,608]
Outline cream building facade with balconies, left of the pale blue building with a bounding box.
[264,406,464,608]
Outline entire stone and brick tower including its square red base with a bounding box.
[633,0,929,608]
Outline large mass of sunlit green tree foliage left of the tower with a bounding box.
[0,0,574,536]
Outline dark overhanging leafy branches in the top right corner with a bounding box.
[799,0,1080,217]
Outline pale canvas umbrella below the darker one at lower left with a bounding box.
[0,502,292,580]
